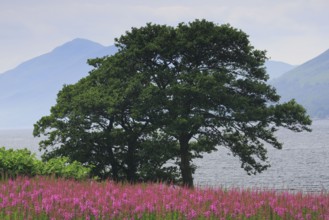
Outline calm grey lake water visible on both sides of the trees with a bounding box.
[0,120,329,191]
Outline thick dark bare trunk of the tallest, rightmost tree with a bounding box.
[179,137,193,188]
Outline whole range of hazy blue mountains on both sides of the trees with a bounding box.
[0,38,329,129]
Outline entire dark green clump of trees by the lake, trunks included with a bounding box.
[34,20,311,187]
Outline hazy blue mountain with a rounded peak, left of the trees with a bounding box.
[0,38,117,129]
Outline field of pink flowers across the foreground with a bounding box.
[0,177,329,220]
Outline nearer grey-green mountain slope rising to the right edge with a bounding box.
[271,50,329,118]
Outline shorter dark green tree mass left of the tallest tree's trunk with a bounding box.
[34,54,177,182]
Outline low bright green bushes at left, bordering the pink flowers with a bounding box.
[0,147,91,180]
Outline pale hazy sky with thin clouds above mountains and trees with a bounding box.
[0,0,329,73]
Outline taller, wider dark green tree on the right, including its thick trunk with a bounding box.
[110,20,311,187]
